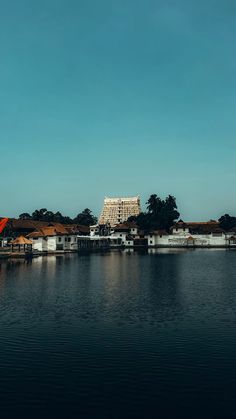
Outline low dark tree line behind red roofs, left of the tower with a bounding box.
[19,208,97,226]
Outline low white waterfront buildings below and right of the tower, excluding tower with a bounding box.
[78,220,236,248]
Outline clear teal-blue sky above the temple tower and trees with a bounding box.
[0,0,236,220]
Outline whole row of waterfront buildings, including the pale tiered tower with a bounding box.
[1,196,236,254]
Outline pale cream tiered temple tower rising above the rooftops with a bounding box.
[99,196,141,226]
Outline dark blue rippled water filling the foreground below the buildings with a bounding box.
[0,250,236,419]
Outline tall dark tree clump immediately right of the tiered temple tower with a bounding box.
[129,194,180,231]
